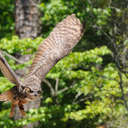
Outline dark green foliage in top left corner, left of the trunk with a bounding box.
[0,0,14,38]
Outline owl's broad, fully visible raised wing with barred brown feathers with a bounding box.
[26,14,83,81]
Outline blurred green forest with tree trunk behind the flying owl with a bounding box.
[0,0,128,128]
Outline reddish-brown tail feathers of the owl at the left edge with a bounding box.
[0,90,12,102]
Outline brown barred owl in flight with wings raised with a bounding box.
[0,14,83,117]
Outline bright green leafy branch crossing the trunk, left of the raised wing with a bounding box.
[0,36,43,55]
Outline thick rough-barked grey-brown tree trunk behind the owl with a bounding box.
[14,0,41,128]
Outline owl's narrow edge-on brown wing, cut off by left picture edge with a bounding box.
[0,52,19,86]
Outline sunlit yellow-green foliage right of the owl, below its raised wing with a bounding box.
[47,46,126,123]
